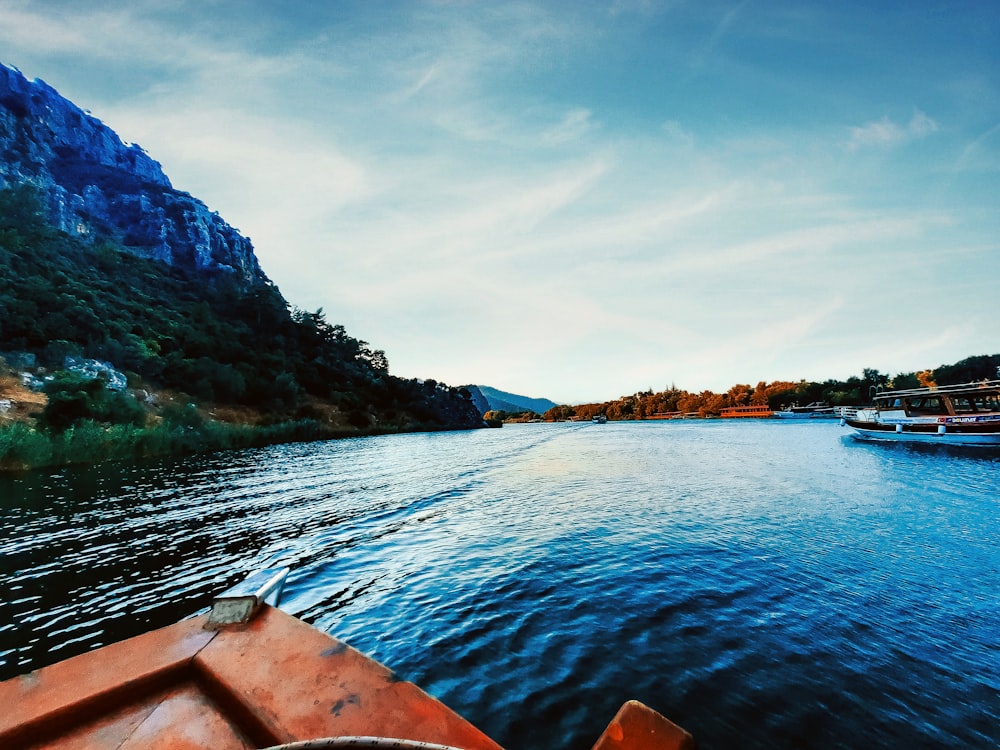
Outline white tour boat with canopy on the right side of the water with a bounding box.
[841,380,1000,446]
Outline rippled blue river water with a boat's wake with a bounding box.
[0,421,1000,750]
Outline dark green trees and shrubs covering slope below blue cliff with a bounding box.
[0,187,480,470]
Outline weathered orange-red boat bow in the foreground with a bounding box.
[0,569,694,750]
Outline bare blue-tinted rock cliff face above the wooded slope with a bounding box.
[0,64,268,286]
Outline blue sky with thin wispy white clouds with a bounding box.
[0,0,1000,403]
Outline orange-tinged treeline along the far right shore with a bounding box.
[542,354,1000,421]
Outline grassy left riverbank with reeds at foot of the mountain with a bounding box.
[0,359,484,472]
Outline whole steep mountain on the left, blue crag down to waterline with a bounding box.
[0,64,484,458]
